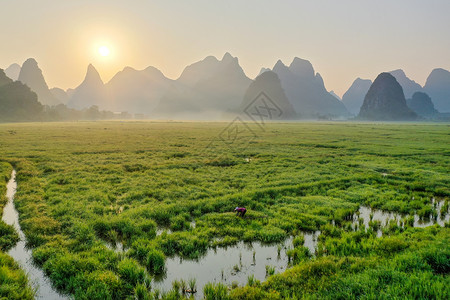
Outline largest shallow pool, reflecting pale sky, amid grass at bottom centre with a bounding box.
[152,231,320,299]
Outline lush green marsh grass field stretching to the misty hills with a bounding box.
[0,122,450,299]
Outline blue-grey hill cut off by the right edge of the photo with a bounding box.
[424,69,450,113]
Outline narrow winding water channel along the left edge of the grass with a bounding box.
[2,171,69,300]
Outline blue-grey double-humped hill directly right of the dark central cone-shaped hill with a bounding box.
[272,57,349,118]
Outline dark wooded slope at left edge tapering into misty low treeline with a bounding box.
[0,69,131,122]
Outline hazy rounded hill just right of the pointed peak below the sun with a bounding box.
[106,67,173,114]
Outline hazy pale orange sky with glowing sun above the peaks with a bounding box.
[0,0,450,96]
